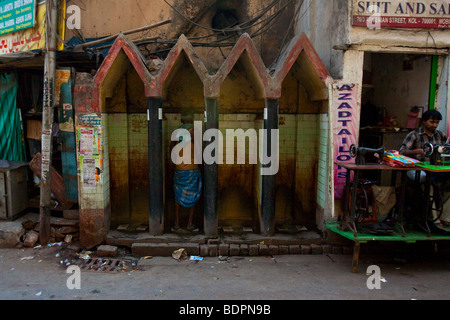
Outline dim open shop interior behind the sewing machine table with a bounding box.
[359,52,433,185]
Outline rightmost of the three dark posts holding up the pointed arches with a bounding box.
[260,99,278,236]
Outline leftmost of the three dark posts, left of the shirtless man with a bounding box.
[147,98,164,236]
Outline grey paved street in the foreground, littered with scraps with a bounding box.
[0,242,450,300]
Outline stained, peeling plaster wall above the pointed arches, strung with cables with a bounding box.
[66,0,302,73]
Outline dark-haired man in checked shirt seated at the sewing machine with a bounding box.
[399,110,450,225]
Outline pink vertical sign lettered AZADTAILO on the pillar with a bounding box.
[333,83,360,199]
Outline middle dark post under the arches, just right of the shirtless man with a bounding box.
[203,98,219,238]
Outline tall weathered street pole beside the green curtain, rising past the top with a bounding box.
[39,0,58,244]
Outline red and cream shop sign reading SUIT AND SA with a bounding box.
[352,0,450,29]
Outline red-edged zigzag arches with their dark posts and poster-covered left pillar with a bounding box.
[74,34,332,247]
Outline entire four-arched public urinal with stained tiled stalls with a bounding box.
[74,34,330,247]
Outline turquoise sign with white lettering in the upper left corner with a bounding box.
[0,0,36,35]
